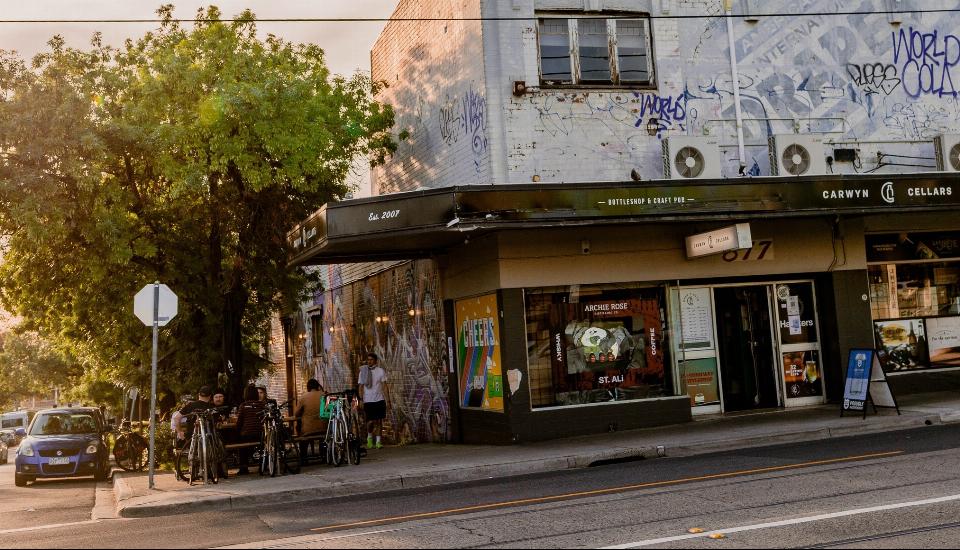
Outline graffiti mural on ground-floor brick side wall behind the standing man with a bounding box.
[304,261,451,444]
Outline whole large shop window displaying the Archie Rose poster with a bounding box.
[526,286,674,408]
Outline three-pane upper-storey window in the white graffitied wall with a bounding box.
[539,17,653,86]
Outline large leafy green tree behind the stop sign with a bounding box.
[0,5,395,406]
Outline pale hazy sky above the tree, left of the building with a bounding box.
[0,0,397,196]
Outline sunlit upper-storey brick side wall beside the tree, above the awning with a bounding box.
[371,0,490,194]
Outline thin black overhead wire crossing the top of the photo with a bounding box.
[0,8,960,24]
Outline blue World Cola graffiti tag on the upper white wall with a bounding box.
[891,27,960,99]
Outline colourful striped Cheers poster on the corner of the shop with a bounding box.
[455,294,503,412]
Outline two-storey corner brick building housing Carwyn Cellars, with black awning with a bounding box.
[282,0,960,442]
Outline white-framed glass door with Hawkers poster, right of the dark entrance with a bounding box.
[774,281,825,407]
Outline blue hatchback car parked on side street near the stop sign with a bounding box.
[14,407,110,487]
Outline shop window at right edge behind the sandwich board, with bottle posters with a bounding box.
[867,232,960,371]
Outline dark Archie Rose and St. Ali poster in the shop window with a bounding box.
[551,290,666,405]
